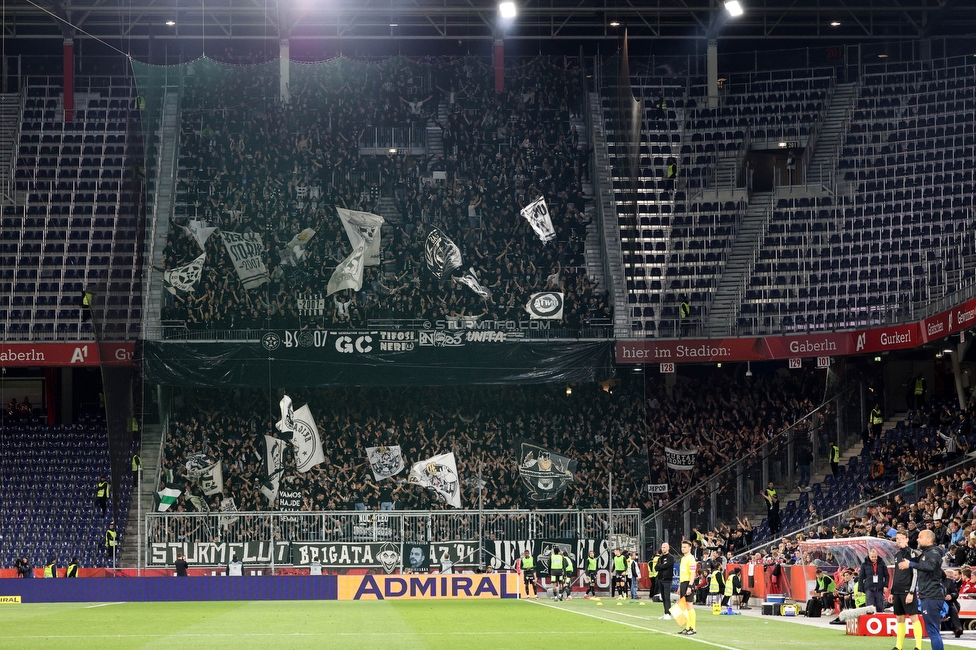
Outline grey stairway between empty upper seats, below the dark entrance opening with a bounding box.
[705,192,773,336]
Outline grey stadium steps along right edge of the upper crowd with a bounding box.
[577,93,631,336]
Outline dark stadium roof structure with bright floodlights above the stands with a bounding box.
[3,0,976,42]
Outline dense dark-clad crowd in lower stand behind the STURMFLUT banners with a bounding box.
[156,368,828,512]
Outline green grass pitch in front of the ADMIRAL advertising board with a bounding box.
[0,599,929,650]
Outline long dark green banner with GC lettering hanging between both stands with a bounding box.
[143,330,614,388]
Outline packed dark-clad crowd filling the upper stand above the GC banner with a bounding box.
[162,58,611,329]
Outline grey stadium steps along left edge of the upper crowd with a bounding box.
[142,90,181,332]
